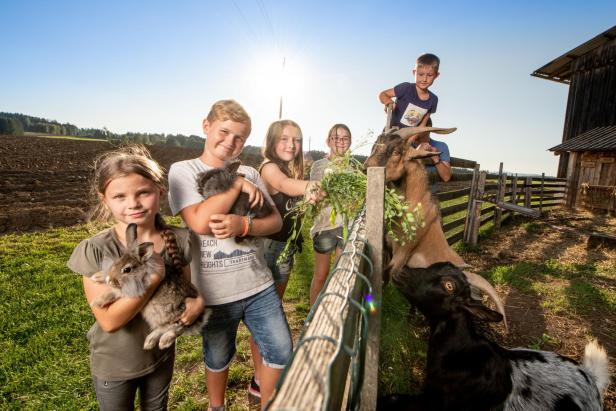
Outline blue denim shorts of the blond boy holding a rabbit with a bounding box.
[201,285,293,372]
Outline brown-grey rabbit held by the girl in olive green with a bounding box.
[92,224,211,350]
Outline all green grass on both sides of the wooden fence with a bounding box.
[0,212,616,410]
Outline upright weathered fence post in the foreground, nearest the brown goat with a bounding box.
[360,167,385,410]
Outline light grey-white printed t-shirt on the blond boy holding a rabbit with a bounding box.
[169,158,273,305]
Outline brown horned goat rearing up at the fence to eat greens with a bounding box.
[365,127,506,326]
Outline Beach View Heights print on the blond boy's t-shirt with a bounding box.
[201,239,257,273]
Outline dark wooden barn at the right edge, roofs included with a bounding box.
[531,26,616,210]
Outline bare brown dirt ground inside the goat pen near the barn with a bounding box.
[462,211,616,410]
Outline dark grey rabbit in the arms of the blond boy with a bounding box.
[197,160,272,242]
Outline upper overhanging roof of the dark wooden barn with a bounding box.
[531,26,616,84]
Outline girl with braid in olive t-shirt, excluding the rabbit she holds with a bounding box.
[68,146,204,410]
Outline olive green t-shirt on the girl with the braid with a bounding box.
[67,228,191,381]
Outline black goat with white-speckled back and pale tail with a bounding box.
[378,263,609,411]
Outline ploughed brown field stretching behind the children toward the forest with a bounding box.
[0,136,219,234]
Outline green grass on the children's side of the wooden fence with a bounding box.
[0,219,313,410]
